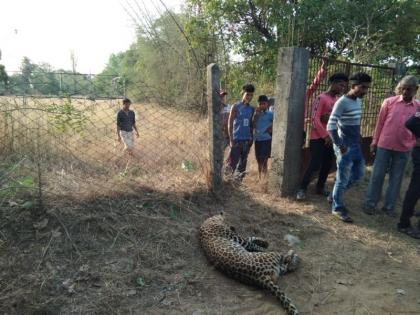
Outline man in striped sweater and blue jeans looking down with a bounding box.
[327,72,372,223]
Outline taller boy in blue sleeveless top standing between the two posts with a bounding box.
[226,84,255,181]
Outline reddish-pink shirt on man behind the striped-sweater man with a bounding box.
[311,92,338,140]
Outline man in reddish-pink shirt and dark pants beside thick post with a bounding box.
[296,73,349,200]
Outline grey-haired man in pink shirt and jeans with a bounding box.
[363,75,420,217]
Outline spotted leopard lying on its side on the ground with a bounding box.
[199,213,300,315]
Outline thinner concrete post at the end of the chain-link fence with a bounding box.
[207,63,223,192]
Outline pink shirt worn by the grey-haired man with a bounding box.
[372,95,420,152]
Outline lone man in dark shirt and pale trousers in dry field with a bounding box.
[117,98,139,156]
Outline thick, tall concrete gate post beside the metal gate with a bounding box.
[269,47,309,197]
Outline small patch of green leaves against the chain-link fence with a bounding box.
[47,97,87,133]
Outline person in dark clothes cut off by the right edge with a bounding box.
[397,108,420,239]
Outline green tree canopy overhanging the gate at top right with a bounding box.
[188,0,420,63]
